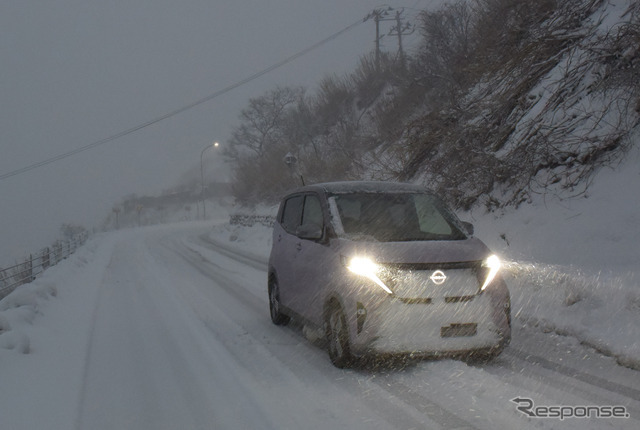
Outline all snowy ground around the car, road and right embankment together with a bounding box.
[0,150,640,430]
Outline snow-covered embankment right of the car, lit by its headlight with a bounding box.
[474,149,640,369]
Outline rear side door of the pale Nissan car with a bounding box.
[273,194,304,310]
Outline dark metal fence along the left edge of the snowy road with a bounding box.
[0,232,89,299]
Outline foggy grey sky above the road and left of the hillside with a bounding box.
[0,0,432,266]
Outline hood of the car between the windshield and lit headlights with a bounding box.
[337,238,491,264]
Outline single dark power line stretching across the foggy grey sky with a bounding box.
[0,19,364,181]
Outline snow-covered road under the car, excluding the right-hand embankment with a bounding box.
[0,223,640,430]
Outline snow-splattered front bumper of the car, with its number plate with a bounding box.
[350,293,511,356]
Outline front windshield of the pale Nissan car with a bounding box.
[330,193,467,242]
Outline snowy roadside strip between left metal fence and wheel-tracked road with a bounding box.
[0,235,118,429]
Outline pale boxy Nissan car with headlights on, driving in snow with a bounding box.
[268,182,511,367]
